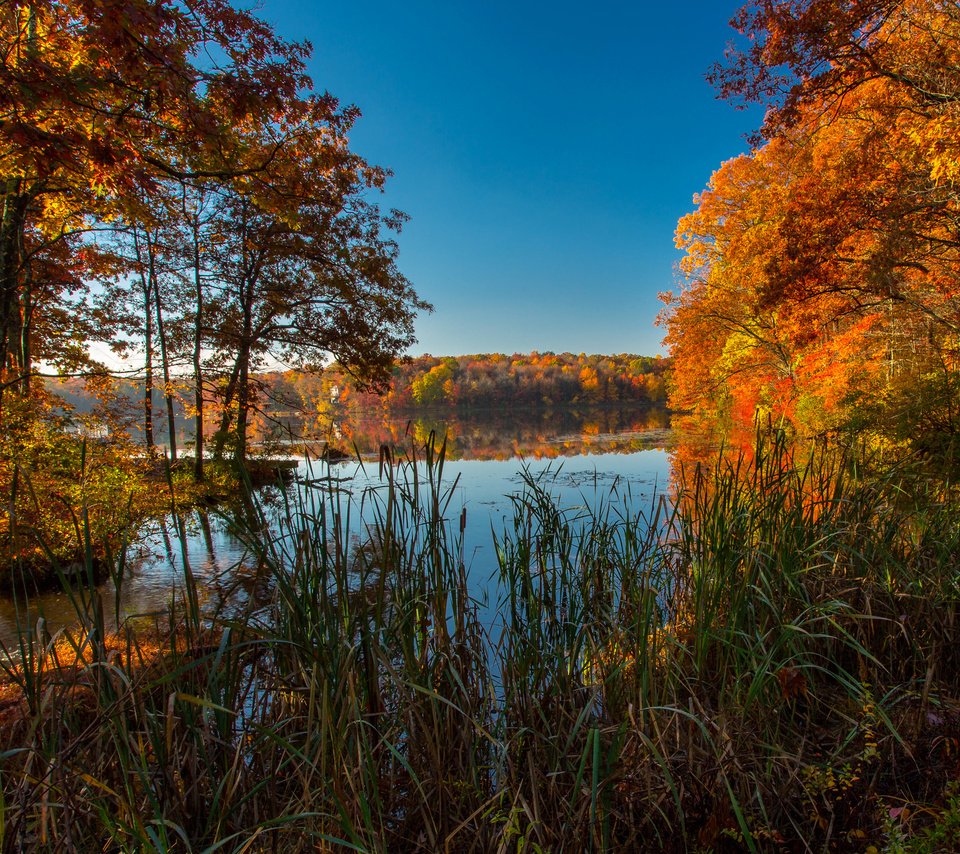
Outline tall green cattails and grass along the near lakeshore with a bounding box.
[0,435,960,852]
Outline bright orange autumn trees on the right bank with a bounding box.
[662,0,960,464]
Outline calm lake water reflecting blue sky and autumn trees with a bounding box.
[0,409,671,653]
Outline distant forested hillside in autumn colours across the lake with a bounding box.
[47,353,670,449]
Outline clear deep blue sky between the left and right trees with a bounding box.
[259,0,760,355]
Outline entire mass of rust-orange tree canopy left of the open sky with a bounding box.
[0,0,429,457]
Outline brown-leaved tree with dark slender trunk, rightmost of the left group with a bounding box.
[195,95,429,459]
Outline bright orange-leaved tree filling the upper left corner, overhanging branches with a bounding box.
[0,0,308,402]
